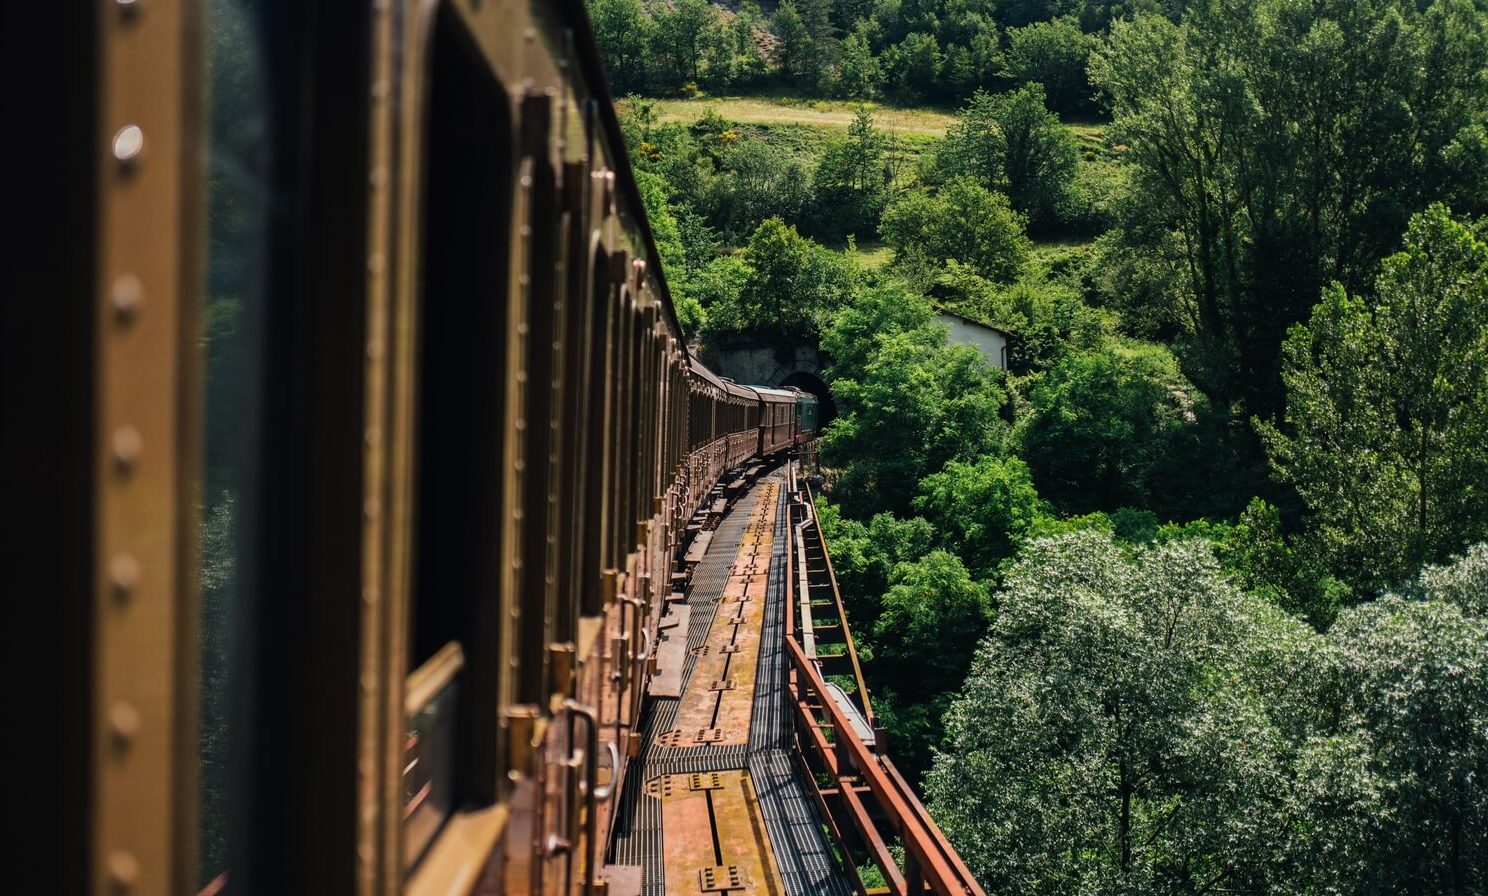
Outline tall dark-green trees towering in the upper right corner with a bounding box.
[1091,0,1488,418]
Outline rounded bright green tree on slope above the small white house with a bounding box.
[879,177,1030,283]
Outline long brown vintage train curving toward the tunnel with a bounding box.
[14,0,818,896]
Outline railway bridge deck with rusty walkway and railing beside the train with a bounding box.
[604,460,981,896]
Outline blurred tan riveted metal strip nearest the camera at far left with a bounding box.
[91,0,202,893]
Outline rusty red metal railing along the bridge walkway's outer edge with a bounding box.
[786,464,985,896]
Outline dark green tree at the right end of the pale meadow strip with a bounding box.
[936,83,1079,225]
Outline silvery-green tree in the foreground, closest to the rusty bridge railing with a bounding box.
[926,531,1327,896]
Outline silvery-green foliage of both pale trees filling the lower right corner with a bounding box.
[927,531,1488,896]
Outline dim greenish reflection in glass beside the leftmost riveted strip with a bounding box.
[198,0,263,889]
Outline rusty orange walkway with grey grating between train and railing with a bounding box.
[609,476,853,896]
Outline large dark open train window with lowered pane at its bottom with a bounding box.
[403,6,512,865]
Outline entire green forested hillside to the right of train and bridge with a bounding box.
[589,0,1488,896]
